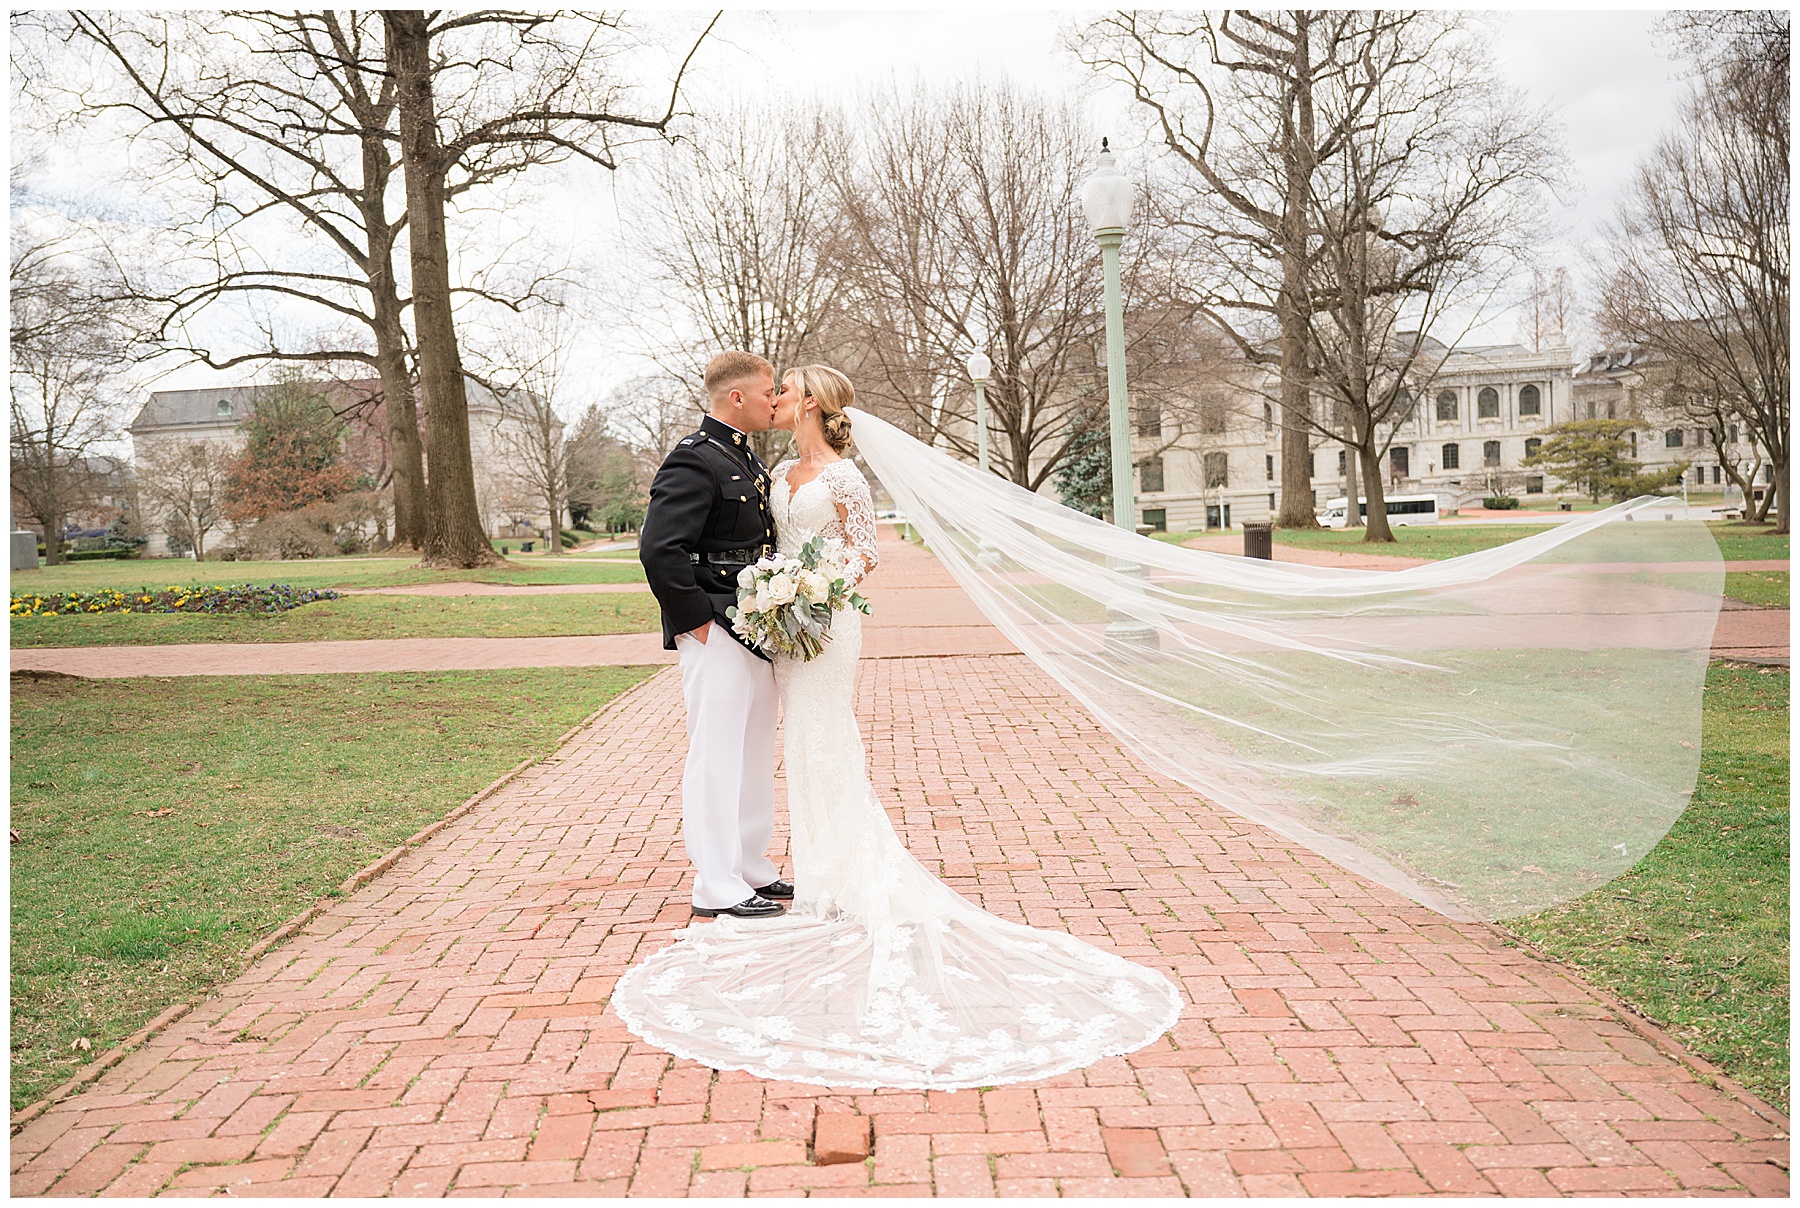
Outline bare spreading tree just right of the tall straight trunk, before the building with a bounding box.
[1305,11,1561,542]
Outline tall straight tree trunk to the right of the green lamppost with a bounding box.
[1276,13,1324,529]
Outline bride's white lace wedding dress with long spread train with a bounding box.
[612,459,1181,1089]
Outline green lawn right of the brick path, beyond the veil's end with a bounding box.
[1507,664,1789,1111]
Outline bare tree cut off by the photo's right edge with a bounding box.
[1598,9,1791,533]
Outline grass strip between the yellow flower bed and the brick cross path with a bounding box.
[11,592,662,648]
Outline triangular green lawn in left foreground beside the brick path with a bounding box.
[11,668,653,1109]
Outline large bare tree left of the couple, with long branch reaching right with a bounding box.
[382,9,716,567]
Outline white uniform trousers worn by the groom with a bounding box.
[675,633,781,911]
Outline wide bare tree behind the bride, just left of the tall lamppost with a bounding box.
[828,83,1186,490]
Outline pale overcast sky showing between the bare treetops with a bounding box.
[31,9,1681,408]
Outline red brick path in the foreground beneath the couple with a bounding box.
[13,532,1787,1195]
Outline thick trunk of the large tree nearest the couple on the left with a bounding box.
[382,9,504,569]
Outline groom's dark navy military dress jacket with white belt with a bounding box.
[637,416,776,659]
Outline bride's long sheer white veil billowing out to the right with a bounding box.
[853,410,1723,920]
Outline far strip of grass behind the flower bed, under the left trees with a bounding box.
[11,554,644,594]
